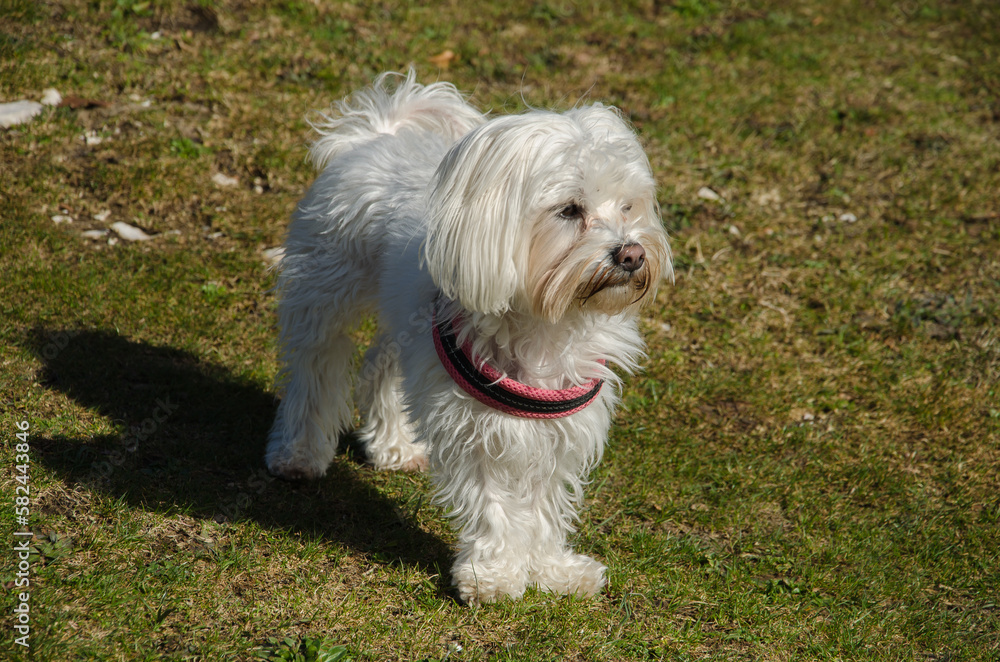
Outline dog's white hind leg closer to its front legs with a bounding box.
[358,336,427,471]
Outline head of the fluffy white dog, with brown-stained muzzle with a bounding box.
[423,104,671,322]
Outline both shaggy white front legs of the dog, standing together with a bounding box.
[433,425,606,603]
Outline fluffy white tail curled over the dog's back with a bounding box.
[309,69,483,170]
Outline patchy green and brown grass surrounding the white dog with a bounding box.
[0,0,1000,662]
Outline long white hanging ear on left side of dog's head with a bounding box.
[422,116,544,314]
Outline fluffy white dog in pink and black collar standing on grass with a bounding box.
[267,71,672,603]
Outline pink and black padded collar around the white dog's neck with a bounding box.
[433,310,604,418]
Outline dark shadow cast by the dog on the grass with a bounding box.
[24,328,450,593]
